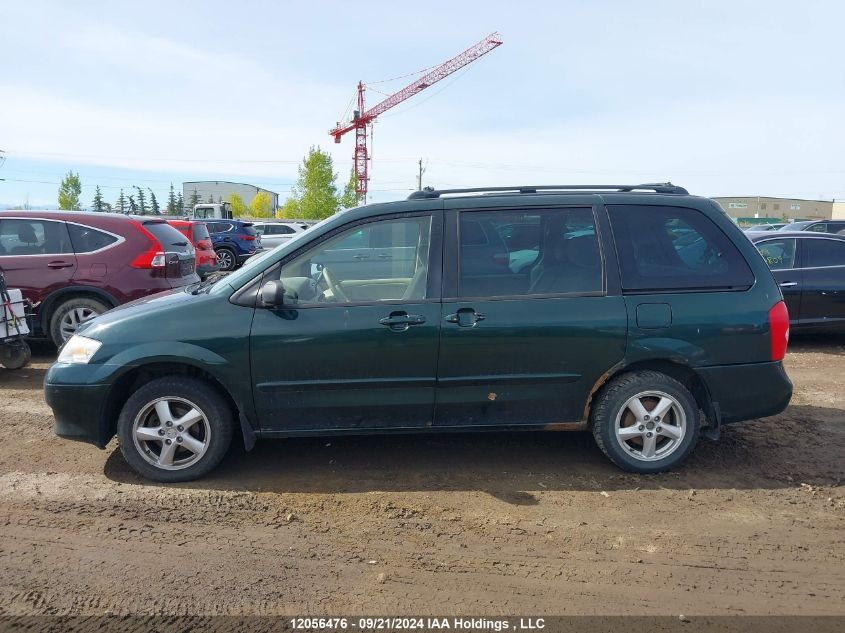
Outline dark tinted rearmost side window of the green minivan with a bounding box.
[608,205,754,291]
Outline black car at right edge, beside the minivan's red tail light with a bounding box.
[751,231,845,331]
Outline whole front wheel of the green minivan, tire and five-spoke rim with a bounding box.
[117,376,234,483]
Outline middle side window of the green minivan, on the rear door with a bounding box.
[458,208,602,297]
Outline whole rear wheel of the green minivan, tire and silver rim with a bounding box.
[590,371,701,473]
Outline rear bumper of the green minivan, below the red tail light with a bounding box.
[696,361,792,424]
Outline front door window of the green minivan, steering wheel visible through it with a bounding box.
[274,216,431,305]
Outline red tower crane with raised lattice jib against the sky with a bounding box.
[329,33,502,201]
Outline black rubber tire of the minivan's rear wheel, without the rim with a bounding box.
[593,371,701,473]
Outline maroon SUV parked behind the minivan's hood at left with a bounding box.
[0,211,199,345]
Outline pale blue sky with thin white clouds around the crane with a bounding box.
[0,0,845,206]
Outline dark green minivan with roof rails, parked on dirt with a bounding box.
[44,183,792,482]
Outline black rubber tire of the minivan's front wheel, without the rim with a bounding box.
[117,376,234,483]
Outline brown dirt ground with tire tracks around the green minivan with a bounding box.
[0,337,845,616]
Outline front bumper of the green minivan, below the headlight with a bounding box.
[44,365,114,448]
